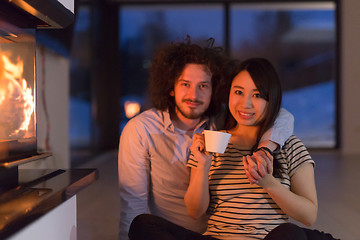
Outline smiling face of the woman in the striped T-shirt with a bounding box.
[229,70,268,126]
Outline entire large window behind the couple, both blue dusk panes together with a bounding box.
[119,1,338,148]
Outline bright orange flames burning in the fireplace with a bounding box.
[0,52,35,138]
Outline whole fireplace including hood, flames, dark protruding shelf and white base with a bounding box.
[0,0,98,239]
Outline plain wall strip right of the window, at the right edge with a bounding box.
[340,0,360,155]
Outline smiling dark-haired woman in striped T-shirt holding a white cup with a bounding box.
[129,58,333,239]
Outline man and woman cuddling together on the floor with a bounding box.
[118,39,338,239]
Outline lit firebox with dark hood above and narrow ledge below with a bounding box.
[0,0,74,193]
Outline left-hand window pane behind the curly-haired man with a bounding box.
[119,4,224,129]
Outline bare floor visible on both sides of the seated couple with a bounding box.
[77,151,360,240]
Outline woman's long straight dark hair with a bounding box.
[224,58,282,175]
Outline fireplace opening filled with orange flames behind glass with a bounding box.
[0,20,37,164]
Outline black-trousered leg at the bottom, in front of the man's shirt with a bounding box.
[129,214,215,240]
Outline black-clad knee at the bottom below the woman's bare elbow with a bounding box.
[264,223,307,240]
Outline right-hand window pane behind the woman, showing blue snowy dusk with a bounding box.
[230,2,338,148]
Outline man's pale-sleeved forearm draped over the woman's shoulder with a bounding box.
[259,108,294,151]
